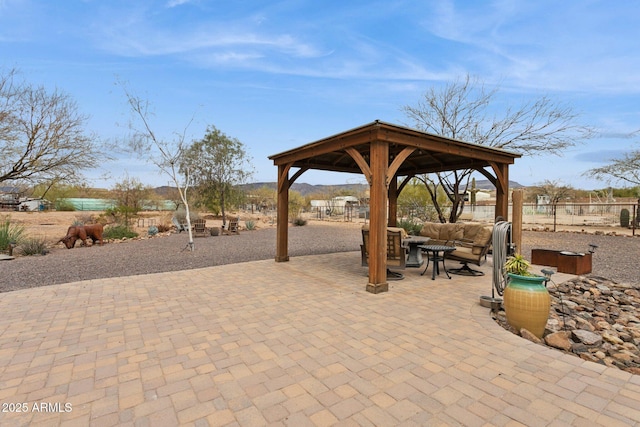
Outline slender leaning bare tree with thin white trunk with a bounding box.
[121,84,195,251]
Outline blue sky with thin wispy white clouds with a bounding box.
[0,0,640,189]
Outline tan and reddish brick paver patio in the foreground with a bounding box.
[0,252,640,426]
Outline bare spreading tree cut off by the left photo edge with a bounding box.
[0,69,106,184]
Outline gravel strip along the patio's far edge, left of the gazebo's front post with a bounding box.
[0,223,362,292]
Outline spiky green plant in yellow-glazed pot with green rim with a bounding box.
[504,254,551,338]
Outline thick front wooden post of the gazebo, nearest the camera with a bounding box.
[367,140,389,294]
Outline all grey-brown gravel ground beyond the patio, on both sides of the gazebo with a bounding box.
[0,227,640,292]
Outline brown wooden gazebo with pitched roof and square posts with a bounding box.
[269,120,520,293]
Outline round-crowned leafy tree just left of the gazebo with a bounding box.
[180,126,253,225]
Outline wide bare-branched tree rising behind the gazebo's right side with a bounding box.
[403,75,591,222]
